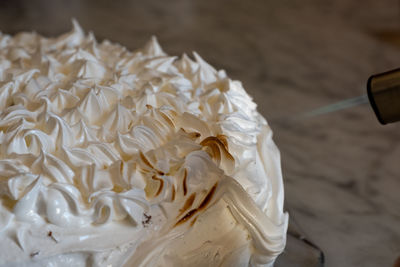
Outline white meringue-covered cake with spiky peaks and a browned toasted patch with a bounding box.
[0,22,288,267]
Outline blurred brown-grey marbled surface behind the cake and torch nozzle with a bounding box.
[0,0,400,266]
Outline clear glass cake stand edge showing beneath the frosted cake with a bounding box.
[274,214,325,267]
